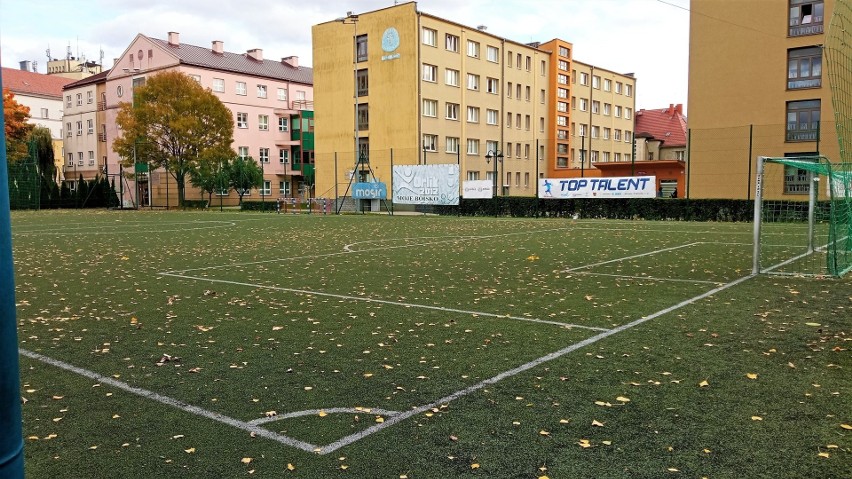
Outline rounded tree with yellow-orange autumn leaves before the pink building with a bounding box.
[113,71,234,205]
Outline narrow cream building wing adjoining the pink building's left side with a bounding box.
[61,71,109,190]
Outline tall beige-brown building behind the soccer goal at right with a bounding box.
[688,0,839,200]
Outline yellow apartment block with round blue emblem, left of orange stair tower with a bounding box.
[313,2,552,196]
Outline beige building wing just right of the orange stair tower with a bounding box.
[560,60,636,176]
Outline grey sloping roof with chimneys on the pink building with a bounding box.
[151,38,314,85]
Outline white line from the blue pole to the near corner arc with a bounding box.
[18,349,318,452]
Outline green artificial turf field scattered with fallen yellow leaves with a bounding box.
[12,211,852,478]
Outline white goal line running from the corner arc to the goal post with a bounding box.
[317,275,754,454]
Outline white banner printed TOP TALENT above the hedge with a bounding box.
[538,176,657,198]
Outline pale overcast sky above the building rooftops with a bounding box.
[0,0,689,113]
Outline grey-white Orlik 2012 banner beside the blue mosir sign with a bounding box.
[393,164,459,205]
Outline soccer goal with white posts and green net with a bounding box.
[753,156,852,277]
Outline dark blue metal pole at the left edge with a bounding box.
[0,69,24,479]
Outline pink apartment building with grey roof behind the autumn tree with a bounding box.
[104,32,314,206]
